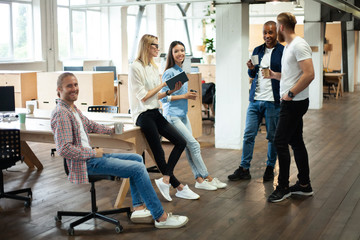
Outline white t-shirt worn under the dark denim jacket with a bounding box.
[254,47,274,101]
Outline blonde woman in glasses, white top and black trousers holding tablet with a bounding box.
[129,34,200,201]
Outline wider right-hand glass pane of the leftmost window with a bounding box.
[12,3,33,59]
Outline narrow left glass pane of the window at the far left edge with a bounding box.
[0,4,11,59]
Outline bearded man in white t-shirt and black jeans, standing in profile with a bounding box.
[268,12,314,202]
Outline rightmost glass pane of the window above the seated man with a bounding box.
[87,11,102,58]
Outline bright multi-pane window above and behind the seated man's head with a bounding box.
[58,0,102,60]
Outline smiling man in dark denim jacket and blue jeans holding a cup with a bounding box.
[228,21,284,181]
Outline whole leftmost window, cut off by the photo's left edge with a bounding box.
[0,1,34,61]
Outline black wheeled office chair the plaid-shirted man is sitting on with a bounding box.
[55,159,131,236]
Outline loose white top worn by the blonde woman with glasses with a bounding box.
[128,60,161,124]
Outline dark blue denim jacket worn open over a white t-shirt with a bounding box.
[248,42,284,103]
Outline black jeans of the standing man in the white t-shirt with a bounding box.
[274,99,310,187]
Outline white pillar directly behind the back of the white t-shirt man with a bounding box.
[304,0,324,109]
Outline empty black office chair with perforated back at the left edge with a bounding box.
[0,129,32,207]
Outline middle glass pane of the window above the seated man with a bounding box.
[72,11,86,58]
